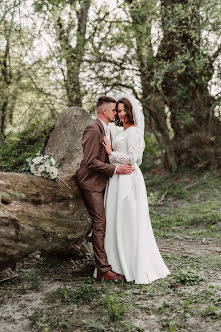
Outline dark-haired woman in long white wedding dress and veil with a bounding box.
[103,96,170,284]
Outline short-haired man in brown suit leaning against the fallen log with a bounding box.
[77,96,133,280]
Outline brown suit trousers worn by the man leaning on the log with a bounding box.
[81,190,112,273]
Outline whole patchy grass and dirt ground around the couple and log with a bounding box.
[0,172,221,332]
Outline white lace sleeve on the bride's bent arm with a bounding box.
[109,128,139,165]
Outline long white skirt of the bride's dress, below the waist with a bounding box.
[104,165,170,284]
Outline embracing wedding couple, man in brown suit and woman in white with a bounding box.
[77,96,170,284]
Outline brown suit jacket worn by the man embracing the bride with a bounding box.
[77,119,115,192]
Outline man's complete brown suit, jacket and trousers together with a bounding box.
[77,119,115,273]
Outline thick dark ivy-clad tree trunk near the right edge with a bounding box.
[157,0,221,167]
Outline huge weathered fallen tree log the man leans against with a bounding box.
[0,107,91,269]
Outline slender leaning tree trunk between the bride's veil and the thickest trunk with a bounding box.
[126,0,177,171]
